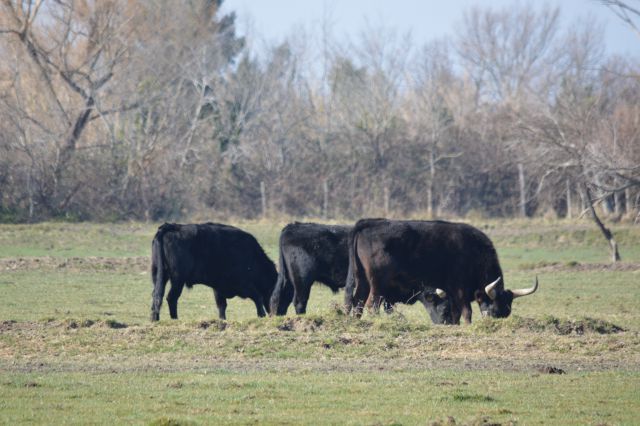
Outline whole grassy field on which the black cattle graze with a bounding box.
[0,221,640,425]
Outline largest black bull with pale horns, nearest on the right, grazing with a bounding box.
[345,219,538,323]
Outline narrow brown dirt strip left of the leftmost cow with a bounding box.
[0,256,151,273]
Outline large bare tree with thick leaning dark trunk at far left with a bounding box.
[0,0,136,213]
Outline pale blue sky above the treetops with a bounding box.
[223,0,640,57]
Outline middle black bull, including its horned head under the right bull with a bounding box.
[271,222,451,324]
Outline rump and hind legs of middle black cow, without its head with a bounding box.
[271,222,351,315]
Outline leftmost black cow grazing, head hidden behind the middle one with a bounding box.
[151,223,278,321]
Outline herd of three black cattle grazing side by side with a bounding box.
[151,219,538,324]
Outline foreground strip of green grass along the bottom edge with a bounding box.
[0,368,640,425]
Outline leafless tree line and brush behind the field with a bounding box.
[0,0,640,233]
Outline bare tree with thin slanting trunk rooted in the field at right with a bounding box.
[521,28,638,262]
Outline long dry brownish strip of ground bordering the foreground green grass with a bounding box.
[0,353,640,376]
